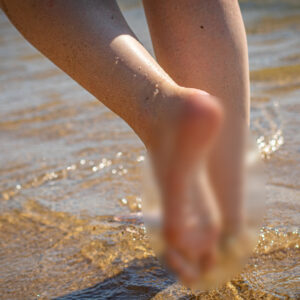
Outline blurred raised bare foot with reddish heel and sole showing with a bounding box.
[149,88,222,284]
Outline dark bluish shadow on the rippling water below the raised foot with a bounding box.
[55,257,191,300]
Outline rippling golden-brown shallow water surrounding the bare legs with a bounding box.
[0,1,300,299]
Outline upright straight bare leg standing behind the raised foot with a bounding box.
[144,0,249,231]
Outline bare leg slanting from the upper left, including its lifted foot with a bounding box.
[2,0,221,278]
